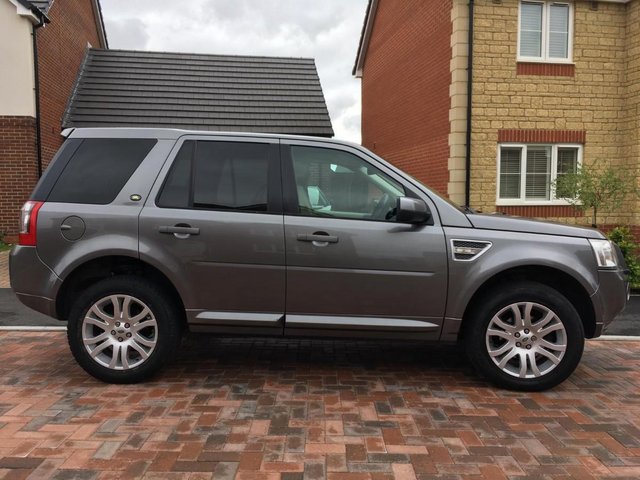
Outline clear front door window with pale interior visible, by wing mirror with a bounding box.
[291,146,405,221]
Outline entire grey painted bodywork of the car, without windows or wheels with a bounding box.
[10,128,626,340]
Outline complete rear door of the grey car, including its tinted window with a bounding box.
[139,137,285,334]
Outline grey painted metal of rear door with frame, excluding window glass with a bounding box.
[139,133,285,333]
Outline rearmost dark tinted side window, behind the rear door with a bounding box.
[47,138,157,205]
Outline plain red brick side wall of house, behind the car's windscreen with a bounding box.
[362,0,452,194]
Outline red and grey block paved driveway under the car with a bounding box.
[0,332,640,480]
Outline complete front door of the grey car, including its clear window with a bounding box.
[281,140,447,339]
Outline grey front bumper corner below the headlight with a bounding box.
[591,270,629,338]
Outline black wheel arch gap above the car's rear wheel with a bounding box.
[56,255,187,327]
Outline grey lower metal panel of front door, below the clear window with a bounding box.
[285,216,447,334]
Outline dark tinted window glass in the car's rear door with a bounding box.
[157,141,269,212]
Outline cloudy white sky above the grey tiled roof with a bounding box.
[100,0,367,143]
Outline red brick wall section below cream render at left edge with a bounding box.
[0,117,38,242]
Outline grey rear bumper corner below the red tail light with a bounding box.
[9,245,61,318]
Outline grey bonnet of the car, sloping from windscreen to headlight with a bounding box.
[468,214,606,238]
